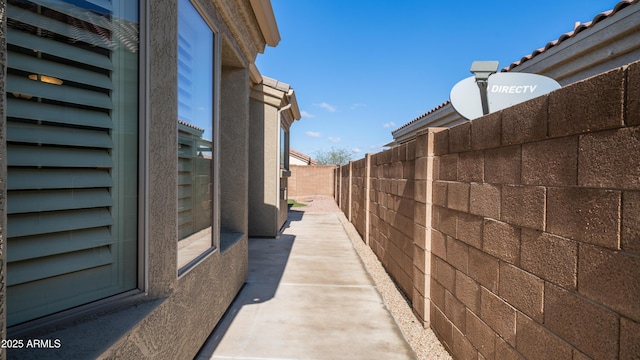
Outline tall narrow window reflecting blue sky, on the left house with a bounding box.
[178,0,215,269]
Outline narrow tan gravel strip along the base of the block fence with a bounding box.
[294,195,451,360]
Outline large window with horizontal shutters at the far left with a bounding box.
[6,0,139,326]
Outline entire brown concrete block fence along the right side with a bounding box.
[334,62,640,359]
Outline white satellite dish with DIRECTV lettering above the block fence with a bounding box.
[450,72,561,120]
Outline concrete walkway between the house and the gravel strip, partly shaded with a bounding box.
[197,211,415,360]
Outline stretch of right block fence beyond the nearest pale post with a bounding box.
[336,142,425,310]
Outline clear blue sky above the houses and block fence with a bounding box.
[256,0,618,159]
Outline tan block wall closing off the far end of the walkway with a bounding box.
[288,165,336,198]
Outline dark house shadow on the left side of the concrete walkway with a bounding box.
[196,210,304,359]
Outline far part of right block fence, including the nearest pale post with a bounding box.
[335,138,433,323]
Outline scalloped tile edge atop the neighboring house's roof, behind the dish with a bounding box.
[392,0,640,133]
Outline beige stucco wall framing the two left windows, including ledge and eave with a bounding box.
[0,0,265,359]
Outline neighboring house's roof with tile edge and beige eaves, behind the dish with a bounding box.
[388,0,640,145]
